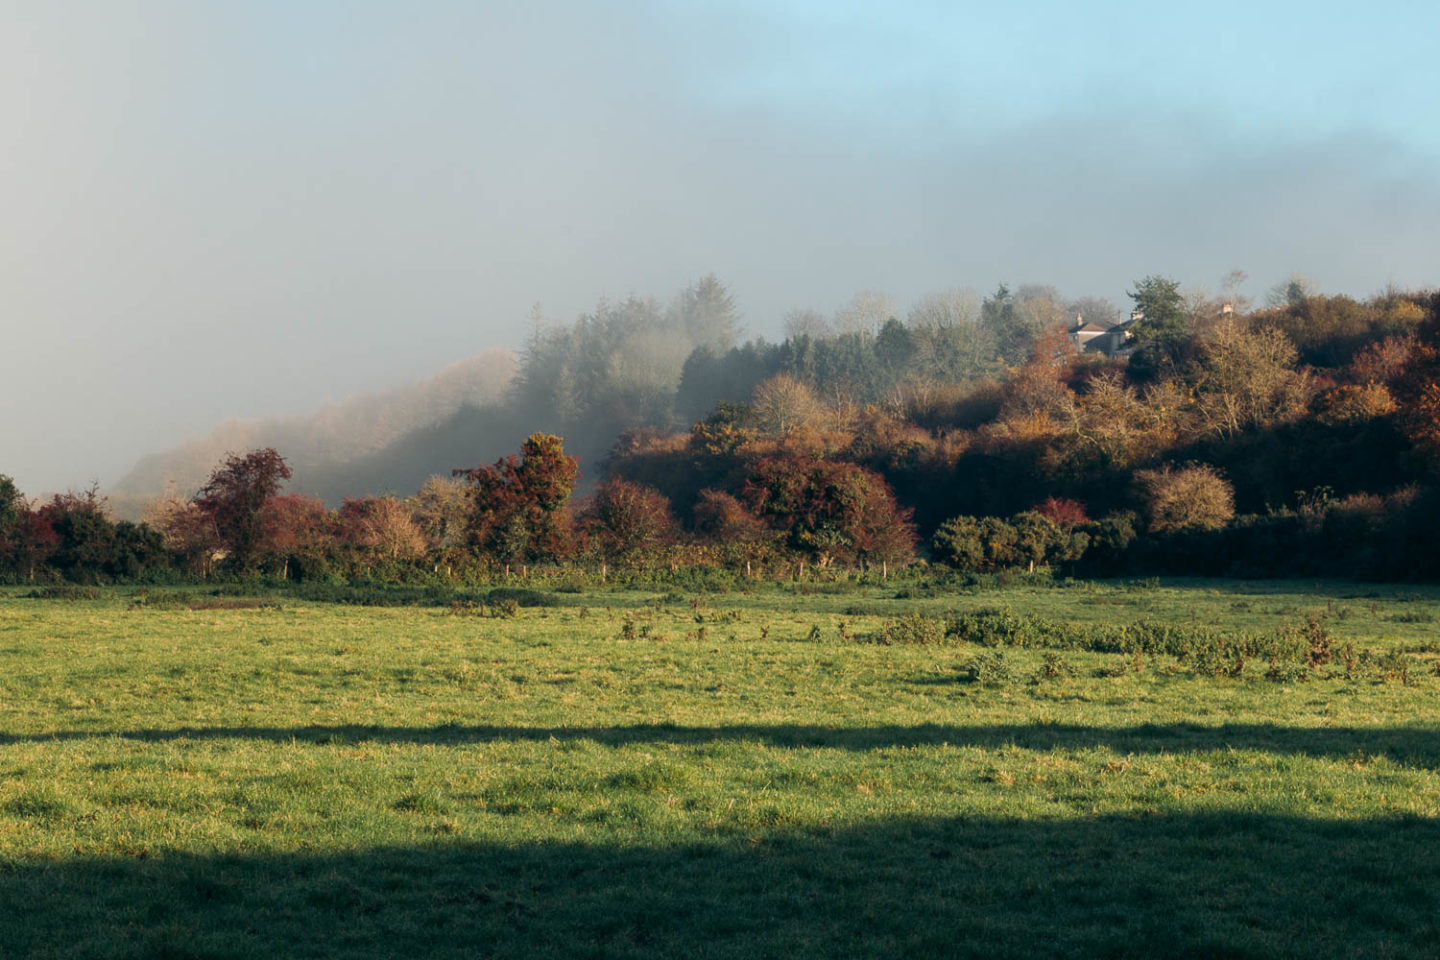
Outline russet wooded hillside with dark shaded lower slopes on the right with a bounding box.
[606,276,1440,579]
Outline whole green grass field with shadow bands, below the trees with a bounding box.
[0,581,1440,959]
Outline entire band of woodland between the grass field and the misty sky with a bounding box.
[0,276,1440,583]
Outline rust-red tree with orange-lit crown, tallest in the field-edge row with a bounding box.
[455,433,580,561]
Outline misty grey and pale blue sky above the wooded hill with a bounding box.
[0,0,1440,494]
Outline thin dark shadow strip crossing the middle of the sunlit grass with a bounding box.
[0,724,1440,769]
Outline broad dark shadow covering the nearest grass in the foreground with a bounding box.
[0,815,1440,959]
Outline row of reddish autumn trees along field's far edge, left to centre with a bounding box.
[0,433,916,583]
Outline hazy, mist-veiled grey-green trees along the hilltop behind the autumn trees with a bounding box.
[315,276,1077,504]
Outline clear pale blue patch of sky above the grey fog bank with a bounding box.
[682,1,1440,148]
